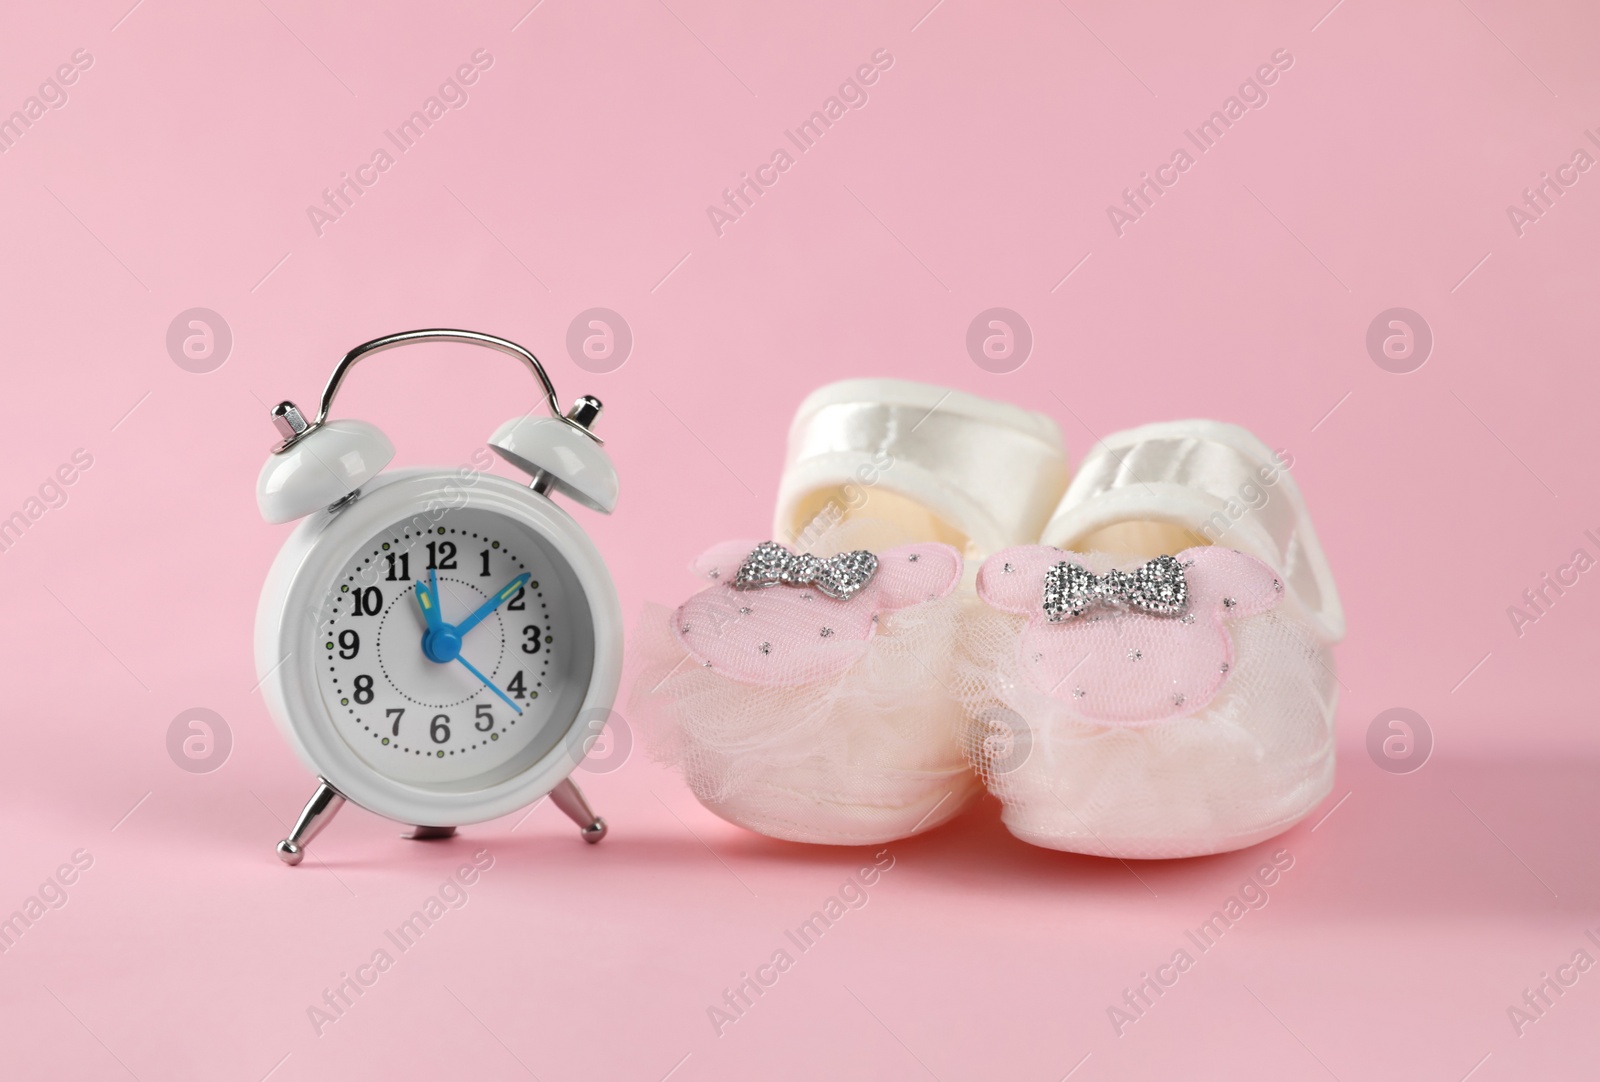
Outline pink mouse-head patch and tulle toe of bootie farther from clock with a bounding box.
[954,546,1338,860]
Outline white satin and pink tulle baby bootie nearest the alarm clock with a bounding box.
[630,379,1067,845]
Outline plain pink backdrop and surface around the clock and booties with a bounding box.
[0,0,1600,1082]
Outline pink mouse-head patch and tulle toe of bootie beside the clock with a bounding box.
[630,543,981,845]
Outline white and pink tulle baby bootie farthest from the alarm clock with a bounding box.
[962,421,1344,858]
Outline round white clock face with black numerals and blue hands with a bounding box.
[314,507,594,791]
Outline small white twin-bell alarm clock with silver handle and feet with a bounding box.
[256,330,622,864]
